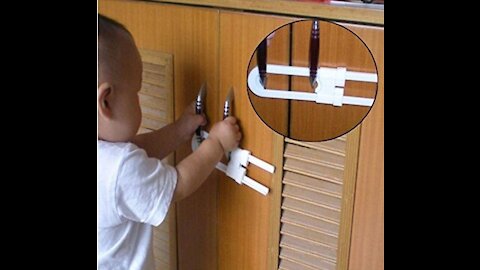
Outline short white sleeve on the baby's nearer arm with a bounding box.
[115,147,177,226]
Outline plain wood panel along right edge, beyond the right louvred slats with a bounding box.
[346,25,384,270]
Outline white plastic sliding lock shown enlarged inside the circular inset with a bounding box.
[248,65,378,107]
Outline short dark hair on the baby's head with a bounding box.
[98,14,132,81]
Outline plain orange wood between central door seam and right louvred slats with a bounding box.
[217,11,293,270]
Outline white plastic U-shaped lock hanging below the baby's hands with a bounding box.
[192,131,275,196]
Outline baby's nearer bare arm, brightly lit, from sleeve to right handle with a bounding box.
[174,117,242,201]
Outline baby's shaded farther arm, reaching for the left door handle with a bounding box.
[132,103,207,159]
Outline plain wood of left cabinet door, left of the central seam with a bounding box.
[99,0,220,270]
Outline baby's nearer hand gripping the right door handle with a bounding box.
[208,116,242,151]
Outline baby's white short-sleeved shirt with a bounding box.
[97,141,177,270]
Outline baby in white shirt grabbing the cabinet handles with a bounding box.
[97,15,241,269]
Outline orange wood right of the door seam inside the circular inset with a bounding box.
[290,20,376,141]
